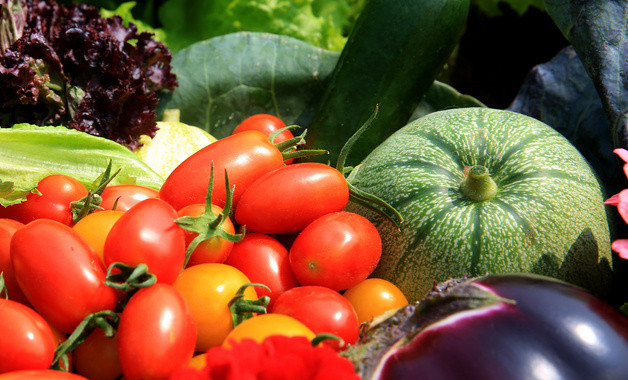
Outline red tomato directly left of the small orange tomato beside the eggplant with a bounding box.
[271,286,360,349]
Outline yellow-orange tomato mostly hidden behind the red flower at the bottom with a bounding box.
[222,313,316,348]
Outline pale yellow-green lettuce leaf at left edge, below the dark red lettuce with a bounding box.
[0,124,163,206]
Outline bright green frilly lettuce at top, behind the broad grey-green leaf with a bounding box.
[159,0,354,52]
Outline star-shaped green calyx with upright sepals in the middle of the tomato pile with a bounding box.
[175,163,246,268]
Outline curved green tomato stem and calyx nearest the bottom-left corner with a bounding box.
[50,310,120,370]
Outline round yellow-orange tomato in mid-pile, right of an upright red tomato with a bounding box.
[173,263,257,352]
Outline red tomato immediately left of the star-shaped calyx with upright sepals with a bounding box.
[103,198,185,284]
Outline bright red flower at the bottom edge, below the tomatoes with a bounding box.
[171,335,360,380]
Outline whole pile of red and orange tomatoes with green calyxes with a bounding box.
[0,115,407,379]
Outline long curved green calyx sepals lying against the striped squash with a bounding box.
[336,105,403,229]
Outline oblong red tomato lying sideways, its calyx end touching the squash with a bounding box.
[235,162,349,234]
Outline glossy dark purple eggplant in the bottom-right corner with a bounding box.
[343,274,628,380]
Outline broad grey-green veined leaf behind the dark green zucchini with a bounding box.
[160,32,482,138]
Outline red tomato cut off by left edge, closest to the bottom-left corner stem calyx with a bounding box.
[0,298,57,373]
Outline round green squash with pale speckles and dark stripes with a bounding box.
[349,108,612,300]
